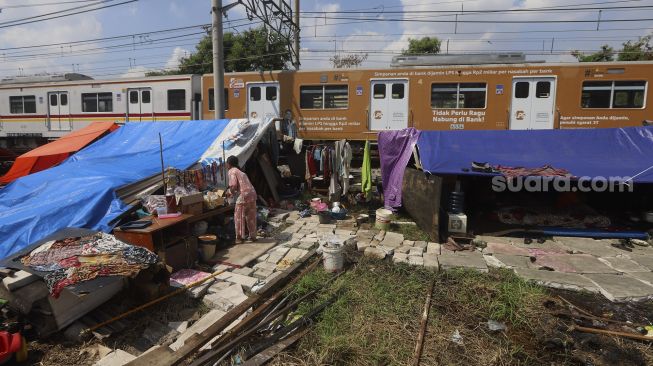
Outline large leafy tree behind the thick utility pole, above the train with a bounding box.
[147,27,290,76]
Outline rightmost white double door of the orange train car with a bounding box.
[510,77,556,130]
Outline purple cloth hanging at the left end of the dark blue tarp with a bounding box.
[378,128,420,209]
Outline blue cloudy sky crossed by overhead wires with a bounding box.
[0,0,653,79]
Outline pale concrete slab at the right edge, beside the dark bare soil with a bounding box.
[585,273,653,302]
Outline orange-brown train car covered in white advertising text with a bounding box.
[202,61,653,140]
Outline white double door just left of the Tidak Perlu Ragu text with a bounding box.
[369,79,408,131]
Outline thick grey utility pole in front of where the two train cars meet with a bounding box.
[211,0,224,119]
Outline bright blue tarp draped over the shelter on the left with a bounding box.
[0,120,229,258]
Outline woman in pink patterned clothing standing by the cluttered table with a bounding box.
[227,156,257,244]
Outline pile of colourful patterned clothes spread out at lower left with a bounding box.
[20,233,159,298]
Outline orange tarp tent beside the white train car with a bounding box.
[0,122,118,184]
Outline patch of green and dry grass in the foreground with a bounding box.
[273,257,568,365]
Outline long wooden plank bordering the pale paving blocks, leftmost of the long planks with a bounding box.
[126,250,315,366]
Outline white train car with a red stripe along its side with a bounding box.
[0,74,201,152]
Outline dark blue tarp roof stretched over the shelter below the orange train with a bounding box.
[417,127,653,183]
